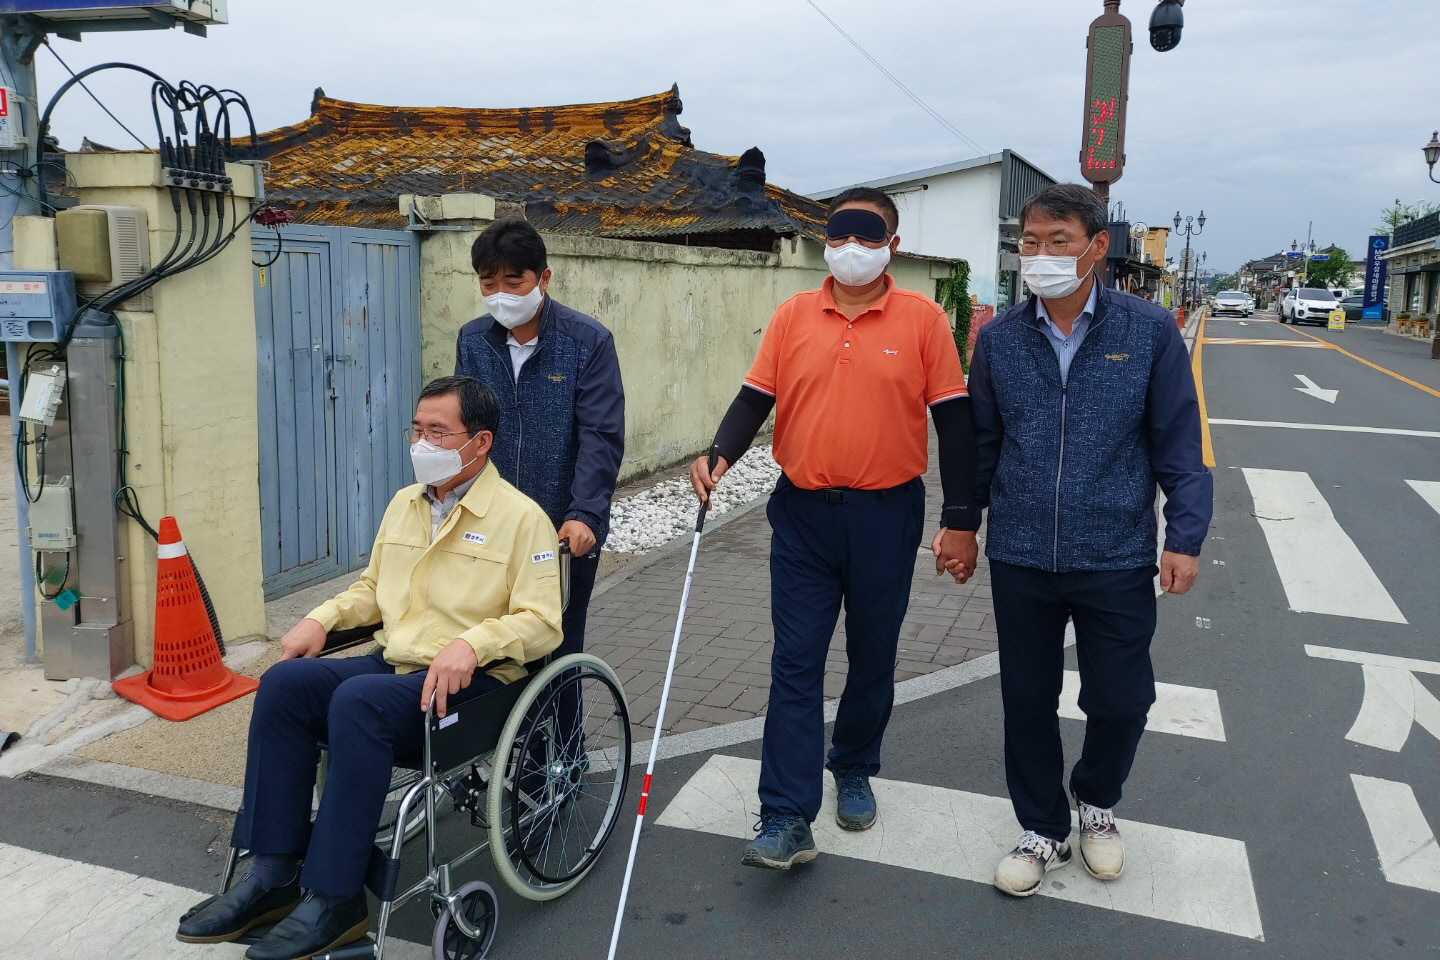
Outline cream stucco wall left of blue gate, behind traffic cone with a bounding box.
[55,154,265,665]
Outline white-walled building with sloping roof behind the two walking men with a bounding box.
[809,150,1056,311]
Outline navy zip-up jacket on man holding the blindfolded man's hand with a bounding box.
[969,288,1212,571]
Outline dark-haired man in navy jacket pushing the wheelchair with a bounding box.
[455,217,625,667]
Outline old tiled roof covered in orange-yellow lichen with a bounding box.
[243,88,824,249]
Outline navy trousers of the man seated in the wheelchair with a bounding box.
[235,651,501,897]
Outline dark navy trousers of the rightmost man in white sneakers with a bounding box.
[991,560,1155,841]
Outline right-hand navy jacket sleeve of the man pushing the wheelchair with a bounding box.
[564,337,625,531]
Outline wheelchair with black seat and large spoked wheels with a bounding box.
[186,541,631,960]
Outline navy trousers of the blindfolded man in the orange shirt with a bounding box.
[760,476,924,822]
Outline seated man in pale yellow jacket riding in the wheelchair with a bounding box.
[176,377,562,960]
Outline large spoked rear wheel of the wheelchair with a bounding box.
[485,653,631,900]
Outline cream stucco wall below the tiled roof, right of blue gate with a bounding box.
[420,224,949,481]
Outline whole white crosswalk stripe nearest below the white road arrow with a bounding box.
[1243,466,1407,623]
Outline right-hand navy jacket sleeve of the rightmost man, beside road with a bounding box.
[1146,324,1214,557]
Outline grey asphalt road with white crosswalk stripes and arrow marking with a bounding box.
[0,317,1440,960]
